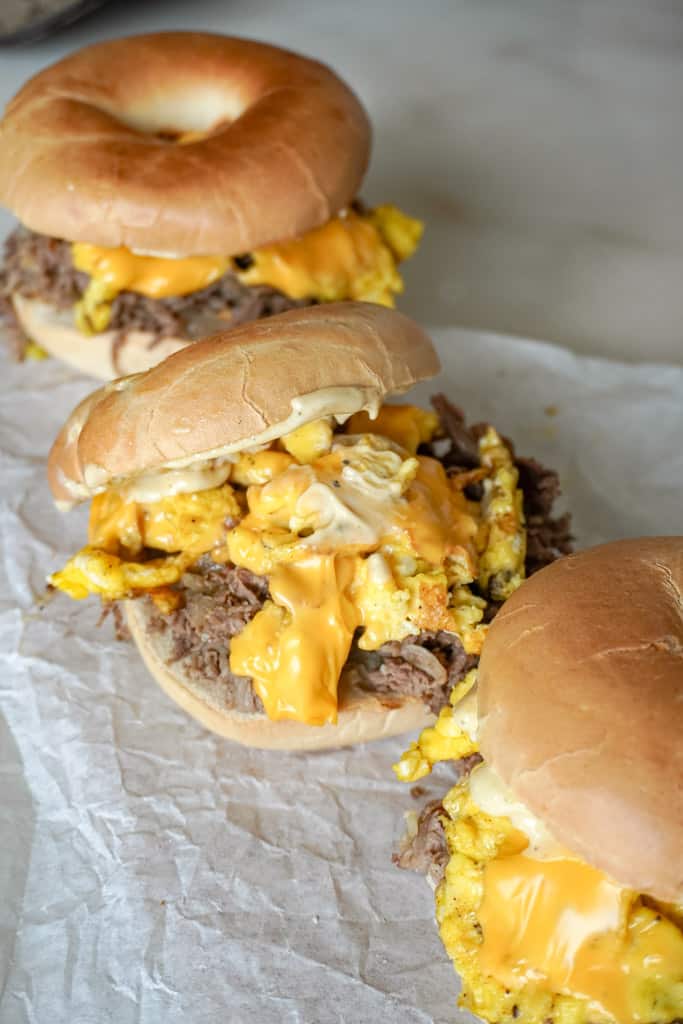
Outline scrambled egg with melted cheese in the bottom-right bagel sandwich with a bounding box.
[436,769,683,1024]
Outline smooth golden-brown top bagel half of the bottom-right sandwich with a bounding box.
[478,537,683,901]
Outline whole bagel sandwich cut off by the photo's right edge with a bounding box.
[396,537,683,1024]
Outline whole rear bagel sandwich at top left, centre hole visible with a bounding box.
[0,32,422,380]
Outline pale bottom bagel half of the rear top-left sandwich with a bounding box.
[12,293,190,381]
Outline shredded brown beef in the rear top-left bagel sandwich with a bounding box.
[0,227,312,366]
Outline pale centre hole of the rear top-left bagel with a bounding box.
[116,88,244,145]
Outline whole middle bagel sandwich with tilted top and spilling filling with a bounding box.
[48,303,568,749]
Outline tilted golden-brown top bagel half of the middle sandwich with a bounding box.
[48,302,439,503]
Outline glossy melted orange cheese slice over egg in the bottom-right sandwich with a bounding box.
[479,854,683,1024]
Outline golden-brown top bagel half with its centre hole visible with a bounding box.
[0,32,371,255]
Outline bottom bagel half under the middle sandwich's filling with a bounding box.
[126,600,434,751]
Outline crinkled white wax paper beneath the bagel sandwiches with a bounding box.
[0,330,683,1024]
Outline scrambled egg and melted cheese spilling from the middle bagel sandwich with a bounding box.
[50,406,524,724]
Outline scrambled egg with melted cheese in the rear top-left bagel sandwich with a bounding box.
[72,206,423,334]
